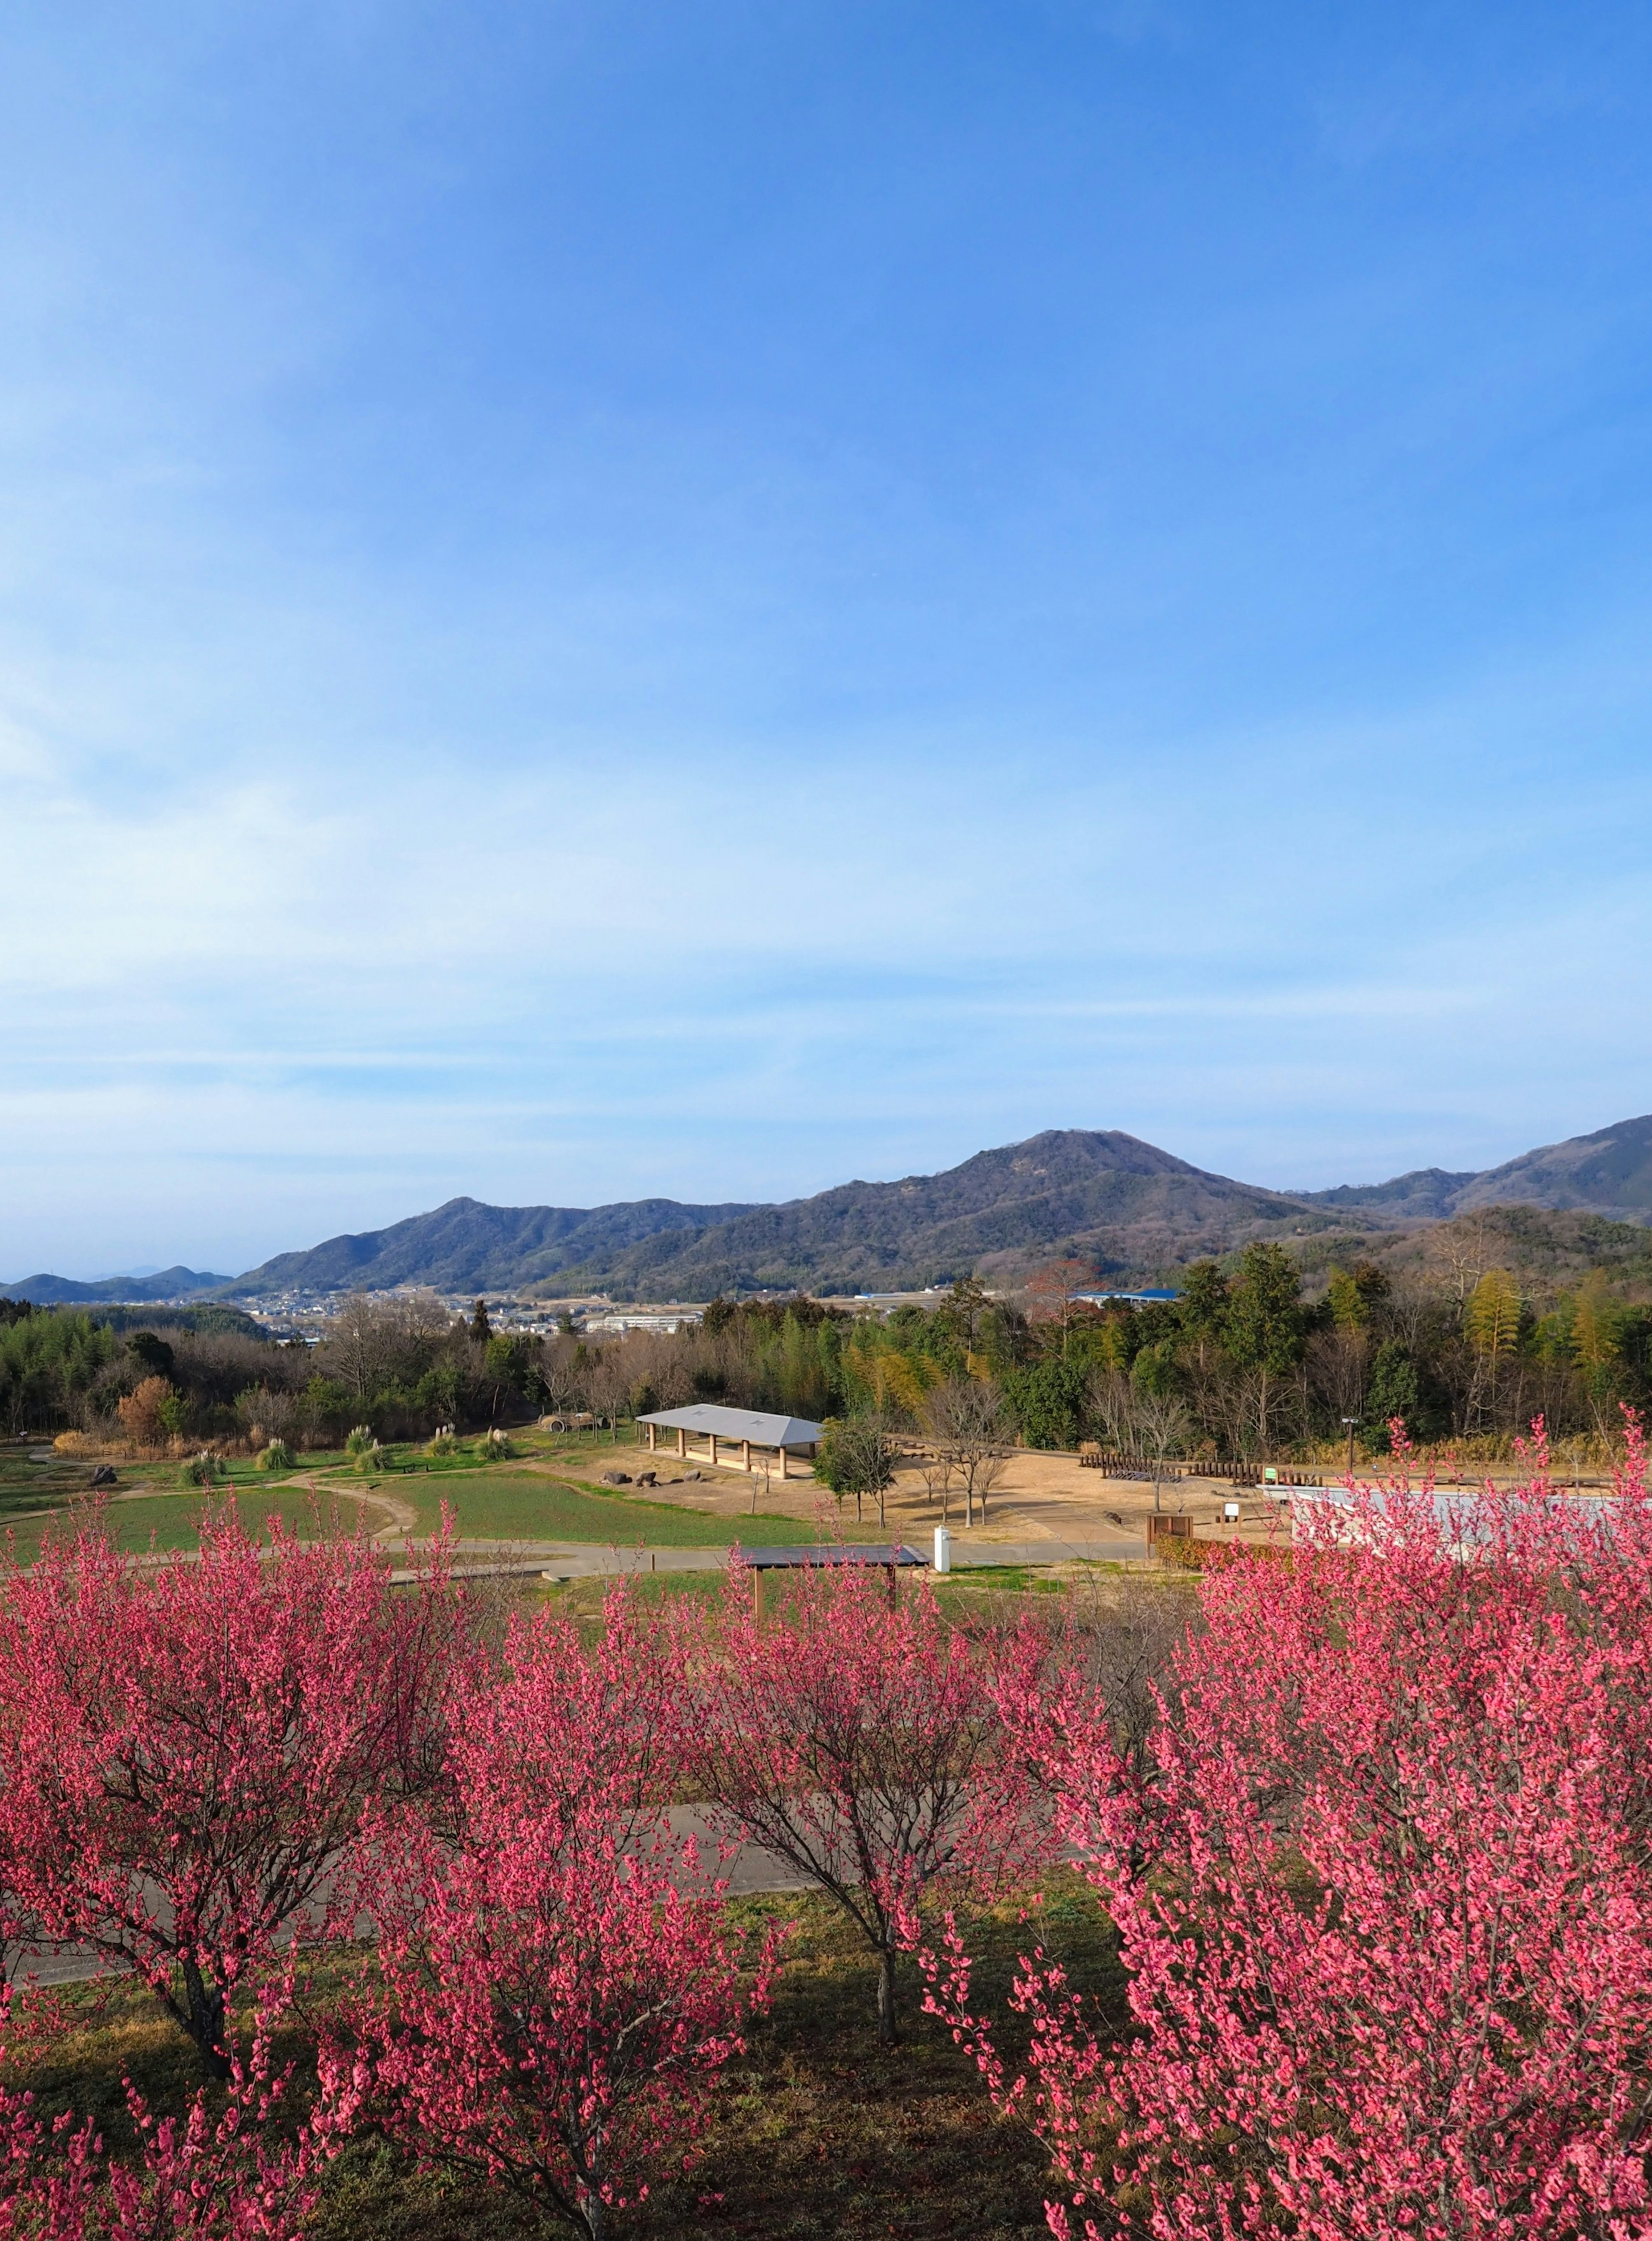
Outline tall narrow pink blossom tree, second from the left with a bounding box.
[347,1591,769,2241]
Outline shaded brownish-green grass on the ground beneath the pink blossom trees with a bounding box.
[7,1874,1123,2241]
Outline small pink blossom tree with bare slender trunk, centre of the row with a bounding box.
[684,1562,1047,2044]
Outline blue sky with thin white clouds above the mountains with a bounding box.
[0,0,1652,1277]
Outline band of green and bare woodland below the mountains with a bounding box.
[0,1242,1652,1459]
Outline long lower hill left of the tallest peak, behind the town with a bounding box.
[224,1199,751,1300]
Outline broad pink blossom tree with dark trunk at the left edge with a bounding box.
[0,1508,464,2078]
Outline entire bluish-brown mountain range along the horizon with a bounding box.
[0,1114,1652,1304]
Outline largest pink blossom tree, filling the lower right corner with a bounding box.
[928,1432,1652,2241]
